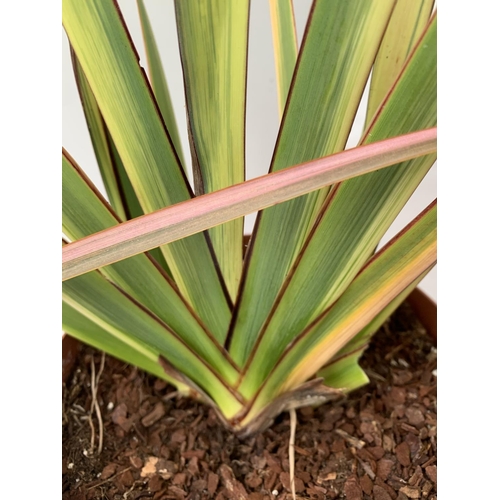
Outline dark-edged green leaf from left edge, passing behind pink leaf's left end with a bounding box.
[62,152,237,384]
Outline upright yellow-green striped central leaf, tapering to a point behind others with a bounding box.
[175,0,249,301]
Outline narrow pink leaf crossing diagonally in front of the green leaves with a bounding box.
[62,127,437,280]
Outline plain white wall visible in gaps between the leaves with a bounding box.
[62,0,436,300]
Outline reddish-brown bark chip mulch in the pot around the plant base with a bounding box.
[62,304,437,500]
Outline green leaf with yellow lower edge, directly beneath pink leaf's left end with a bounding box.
[63,271,241,418]
